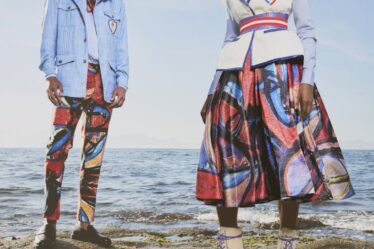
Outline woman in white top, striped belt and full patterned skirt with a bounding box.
[196,0,354,249]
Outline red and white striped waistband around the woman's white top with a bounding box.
[240,12,288,34]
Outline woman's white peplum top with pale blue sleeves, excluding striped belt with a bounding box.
[217,0,316,84]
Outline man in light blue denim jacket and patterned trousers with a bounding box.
[34,0,129,249]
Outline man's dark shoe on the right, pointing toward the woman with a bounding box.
[71,225,112,247]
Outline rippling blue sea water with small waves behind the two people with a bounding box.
[0,149,374,241]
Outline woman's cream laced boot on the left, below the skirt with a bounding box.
[216,227,244,249]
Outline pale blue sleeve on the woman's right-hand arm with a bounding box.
[292,0,317,85]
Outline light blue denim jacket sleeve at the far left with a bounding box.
[39,0,58,78]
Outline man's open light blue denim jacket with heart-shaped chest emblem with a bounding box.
[39,0,129,102]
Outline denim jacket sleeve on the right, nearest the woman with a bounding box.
[116,0,129,90]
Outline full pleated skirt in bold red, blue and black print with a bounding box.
[196,57,354,207]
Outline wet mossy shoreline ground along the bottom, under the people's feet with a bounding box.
[0,228,374,249]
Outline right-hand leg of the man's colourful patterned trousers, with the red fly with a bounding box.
[77,65,112,224]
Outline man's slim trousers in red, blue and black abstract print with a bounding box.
[44,65,112,223]
